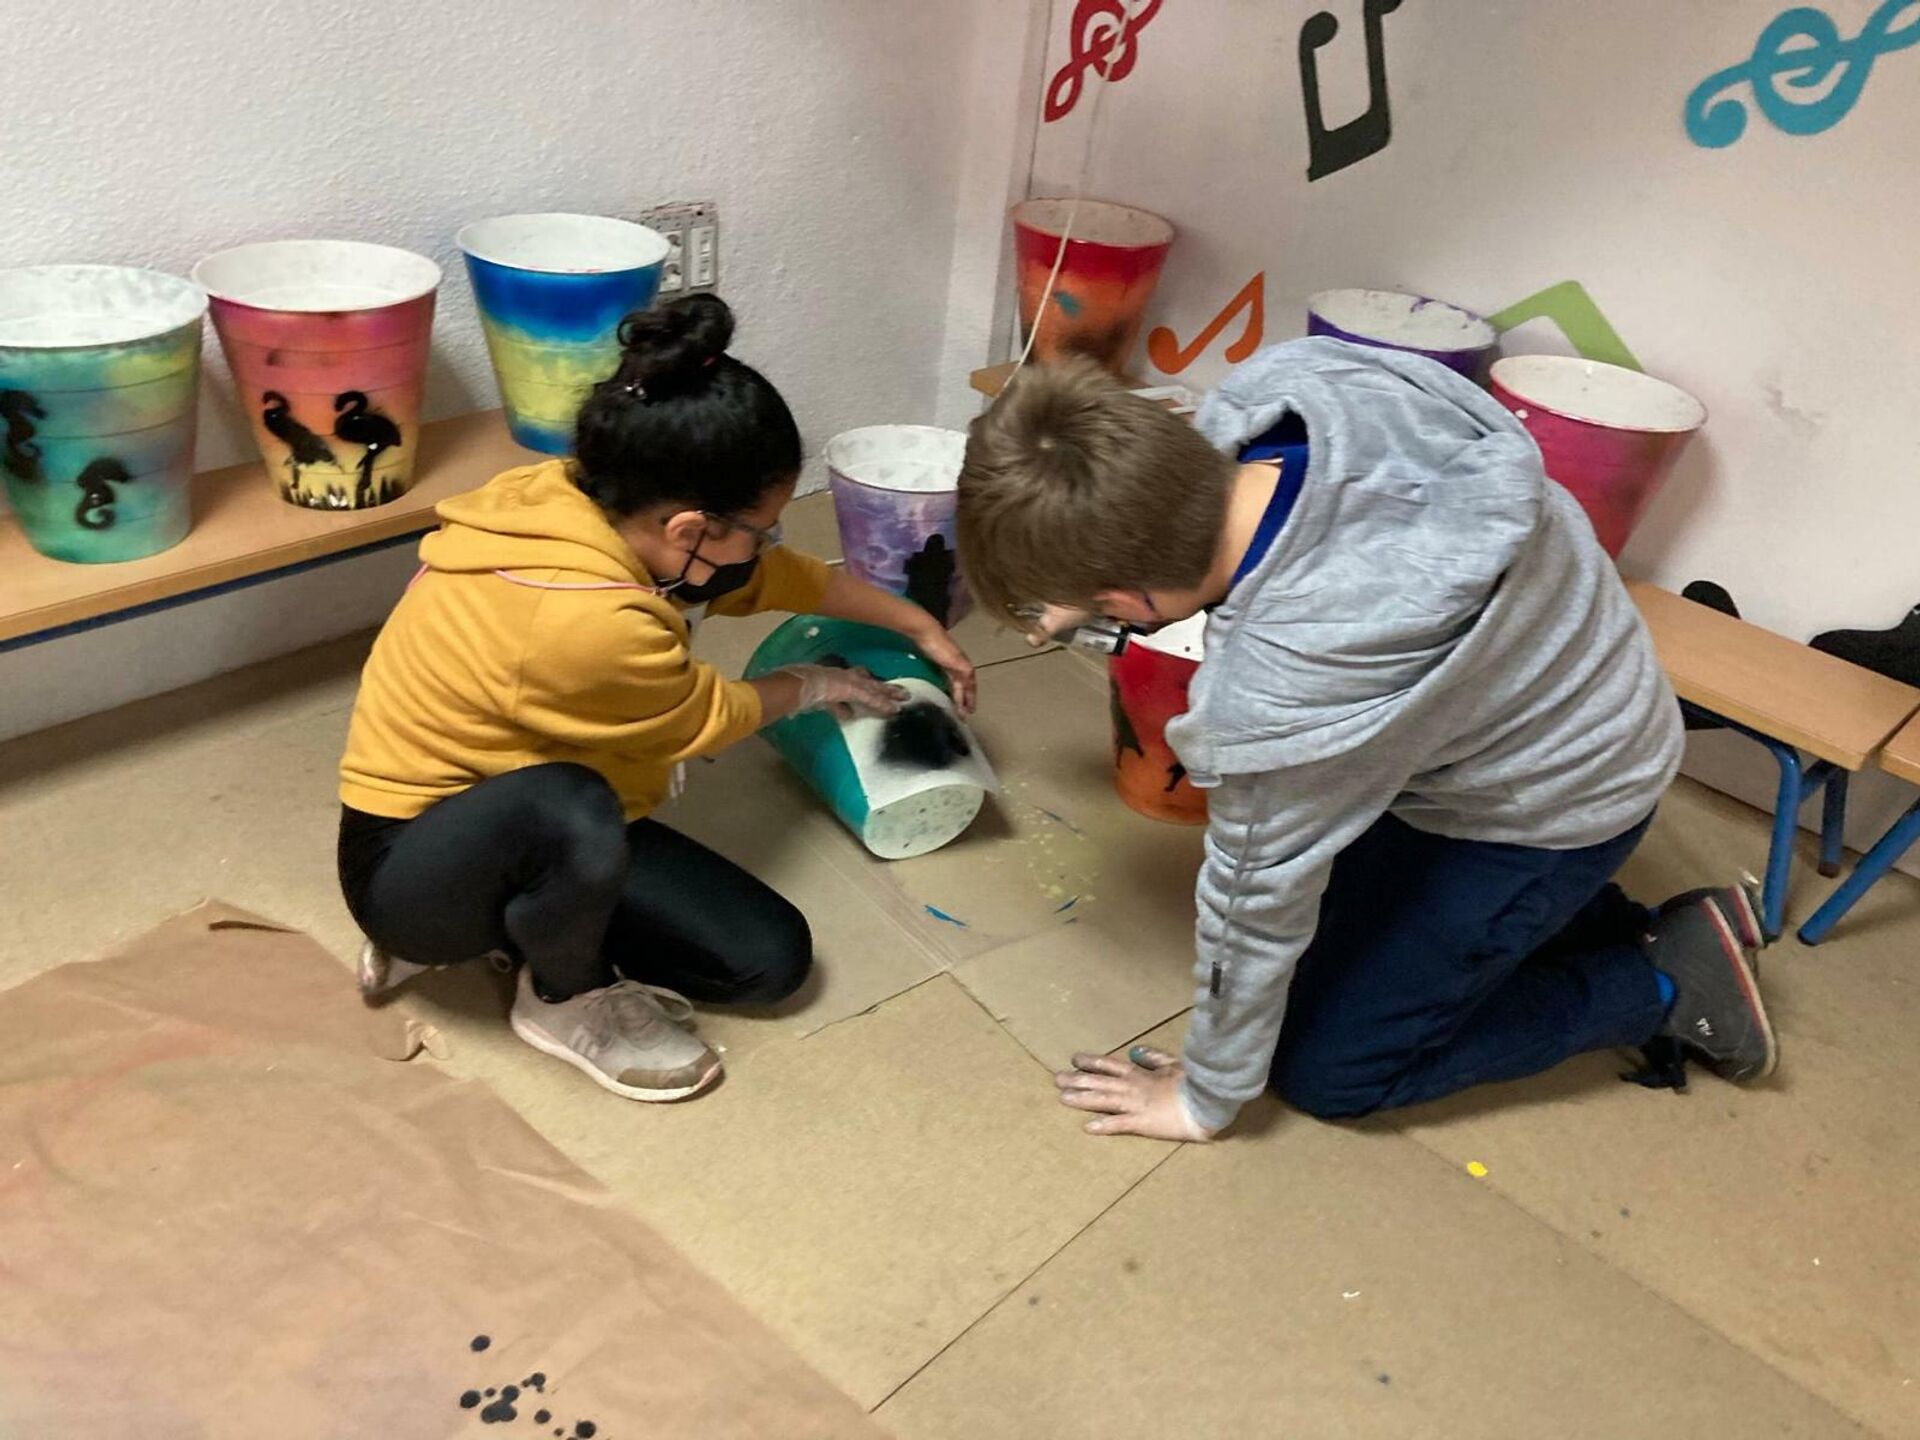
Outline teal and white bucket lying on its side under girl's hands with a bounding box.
[747,614,998,860]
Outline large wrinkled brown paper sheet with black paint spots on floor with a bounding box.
[0,906,879,1440]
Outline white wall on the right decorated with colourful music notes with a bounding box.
[1033,0,1920,875]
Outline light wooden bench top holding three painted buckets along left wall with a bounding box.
[0,409,545,643]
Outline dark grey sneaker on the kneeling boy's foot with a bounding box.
[1647,895,1780,1083]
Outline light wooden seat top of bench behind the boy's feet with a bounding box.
[1626,580,1920,770]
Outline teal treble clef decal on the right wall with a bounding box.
[1686,0,1920,150]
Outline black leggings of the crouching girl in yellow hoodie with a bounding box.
[340,764,812,1004]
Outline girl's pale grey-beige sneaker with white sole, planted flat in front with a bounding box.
[509,966,720,1100]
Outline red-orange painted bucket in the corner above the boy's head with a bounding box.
[1010,196,1173,374]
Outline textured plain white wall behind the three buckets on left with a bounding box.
[0,0,1033,735]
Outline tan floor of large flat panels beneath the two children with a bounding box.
[0,501,1920,1440]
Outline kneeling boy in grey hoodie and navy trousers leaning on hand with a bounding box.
[958,340,1776,1140]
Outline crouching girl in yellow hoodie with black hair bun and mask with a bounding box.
[340,296,973,1100]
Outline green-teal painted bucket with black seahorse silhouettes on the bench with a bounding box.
[0,265,207,564]
